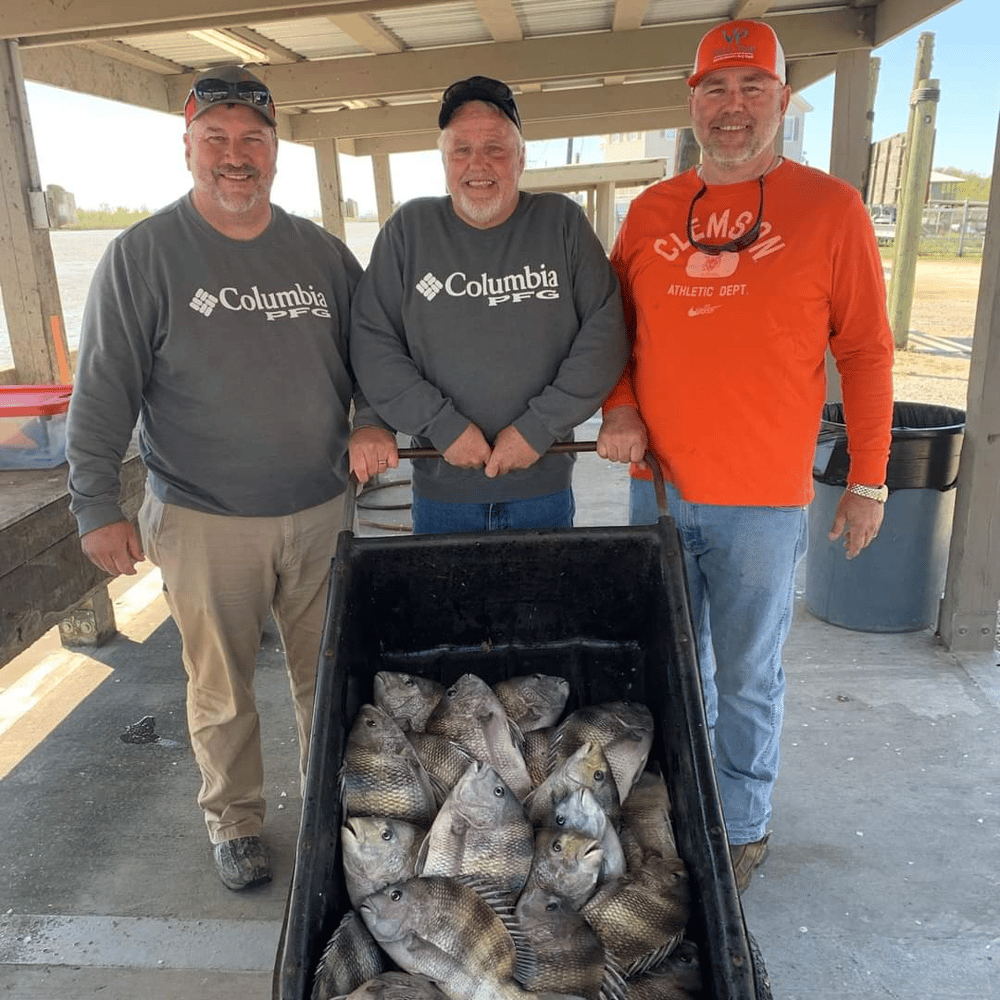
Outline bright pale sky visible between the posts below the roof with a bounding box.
[19,0,1000,215]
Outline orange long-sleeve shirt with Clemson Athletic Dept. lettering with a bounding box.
[604,161,893,506]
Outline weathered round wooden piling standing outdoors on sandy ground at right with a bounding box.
[888,80,941,350]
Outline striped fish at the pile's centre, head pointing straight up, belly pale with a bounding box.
[416,760,534,902]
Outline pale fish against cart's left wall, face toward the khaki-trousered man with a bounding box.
[340,816,427,908]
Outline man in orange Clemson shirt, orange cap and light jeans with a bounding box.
[597,21,892,890]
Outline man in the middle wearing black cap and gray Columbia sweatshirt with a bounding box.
[351,76,628,533]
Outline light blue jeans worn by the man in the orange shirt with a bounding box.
[629,479,807,844]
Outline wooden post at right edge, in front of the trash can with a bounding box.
[938,111,1000,652]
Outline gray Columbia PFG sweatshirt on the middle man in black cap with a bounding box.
[351,192,628,503]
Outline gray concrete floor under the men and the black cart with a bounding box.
[0,423,1000,1000]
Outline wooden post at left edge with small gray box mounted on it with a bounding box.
[0,39,72,385]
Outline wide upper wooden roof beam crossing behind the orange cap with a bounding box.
[160,7,872,110]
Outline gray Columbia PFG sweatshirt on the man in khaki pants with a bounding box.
[66,195,378,534]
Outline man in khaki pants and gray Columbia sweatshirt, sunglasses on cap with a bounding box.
[67,66,395,889]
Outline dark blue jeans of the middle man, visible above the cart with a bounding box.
[411,489,576,535]
